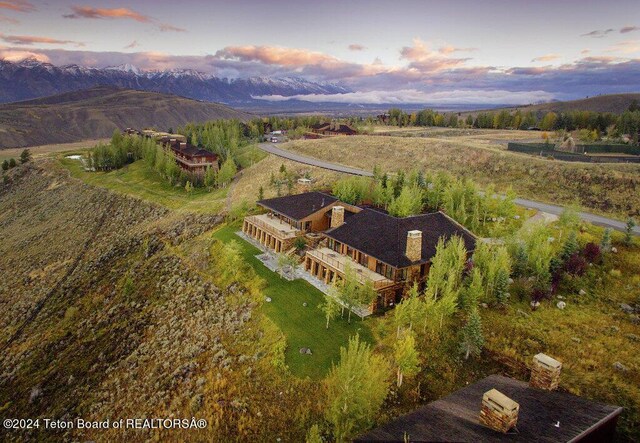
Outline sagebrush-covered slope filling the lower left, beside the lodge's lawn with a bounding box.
[0,162,320,441]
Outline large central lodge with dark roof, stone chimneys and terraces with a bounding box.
[242,192,476,311]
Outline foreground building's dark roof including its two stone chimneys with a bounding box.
[355,354,622,443]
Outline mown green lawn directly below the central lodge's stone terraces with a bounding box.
[213,225,373,379]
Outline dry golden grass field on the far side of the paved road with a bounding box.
[281,134,640,219]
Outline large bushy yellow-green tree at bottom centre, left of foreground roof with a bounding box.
[325,335,391,442]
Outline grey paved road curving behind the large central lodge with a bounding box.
[258,143,640,236]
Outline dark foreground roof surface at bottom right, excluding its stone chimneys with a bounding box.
[355,375,622,443]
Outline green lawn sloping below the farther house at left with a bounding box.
[60,157,227,213]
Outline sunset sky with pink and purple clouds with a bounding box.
[0,0,640,104]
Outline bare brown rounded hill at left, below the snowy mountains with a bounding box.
[0,87,251,149]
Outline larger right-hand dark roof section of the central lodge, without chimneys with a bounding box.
[325,208,476,268]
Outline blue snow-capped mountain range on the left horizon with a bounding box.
[0,58,350,107]
